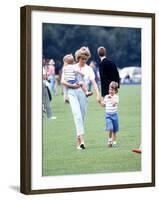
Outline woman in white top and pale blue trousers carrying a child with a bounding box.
[61,47,100,149]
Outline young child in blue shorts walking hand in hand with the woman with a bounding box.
[99,81,119,147]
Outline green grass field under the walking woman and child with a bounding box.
[42,85,141,176]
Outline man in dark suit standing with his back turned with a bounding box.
[97,47,120,97]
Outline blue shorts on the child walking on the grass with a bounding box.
[105,113,119,133]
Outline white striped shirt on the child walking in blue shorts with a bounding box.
[104,94,119,113]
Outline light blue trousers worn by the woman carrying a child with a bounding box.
[68,88,87,136]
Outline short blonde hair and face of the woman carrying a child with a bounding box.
[75,47,91,62]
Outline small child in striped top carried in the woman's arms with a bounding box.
[63,54,93,97]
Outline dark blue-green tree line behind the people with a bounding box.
[42,23,141,68]
